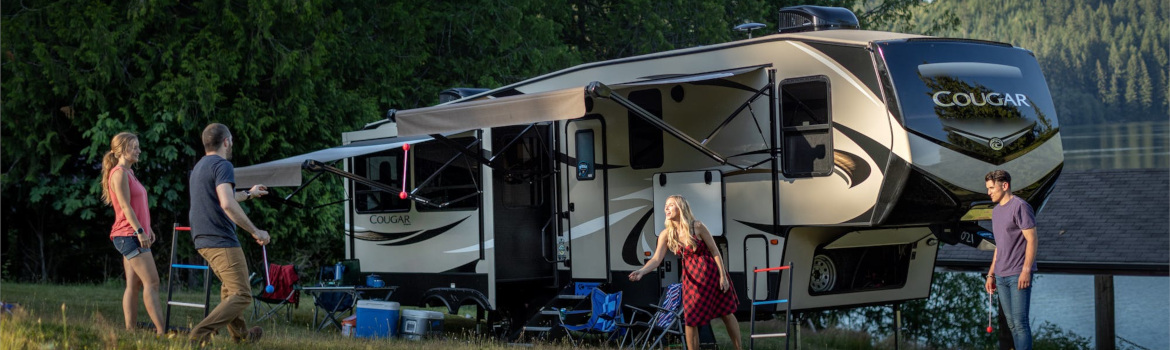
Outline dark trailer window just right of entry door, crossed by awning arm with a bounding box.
[626,89,662,169]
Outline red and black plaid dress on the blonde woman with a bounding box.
[682,229,739,327]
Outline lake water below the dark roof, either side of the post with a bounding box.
[1030,274,1170,349]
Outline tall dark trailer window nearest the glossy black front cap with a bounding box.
[780,76,833,178]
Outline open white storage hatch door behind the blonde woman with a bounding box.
[654,170,729,286]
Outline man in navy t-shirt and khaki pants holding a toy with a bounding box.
[190,123,271,343]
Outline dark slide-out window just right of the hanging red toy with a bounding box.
[408,137,480,212]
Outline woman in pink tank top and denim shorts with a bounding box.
[102,132,165,335]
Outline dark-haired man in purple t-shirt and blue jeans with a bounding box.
[984,170,1038,350]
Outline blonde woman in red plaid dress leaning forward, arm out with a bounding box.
[629,194,741,349]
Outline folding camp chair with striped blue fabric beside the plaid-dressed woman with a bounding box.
[620,283,683,349]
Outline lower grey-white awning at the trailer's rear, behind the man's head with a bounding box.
[235,136,431,188]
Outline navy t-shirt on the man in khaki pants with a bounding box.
[190,155,240,249]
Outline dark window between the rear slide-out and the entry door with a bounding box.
[493,128,552,208]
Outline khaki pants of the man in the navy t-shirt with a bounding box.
[191,247,252,341]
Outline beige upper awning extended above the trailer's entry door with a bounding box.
[395,66,765,136]
